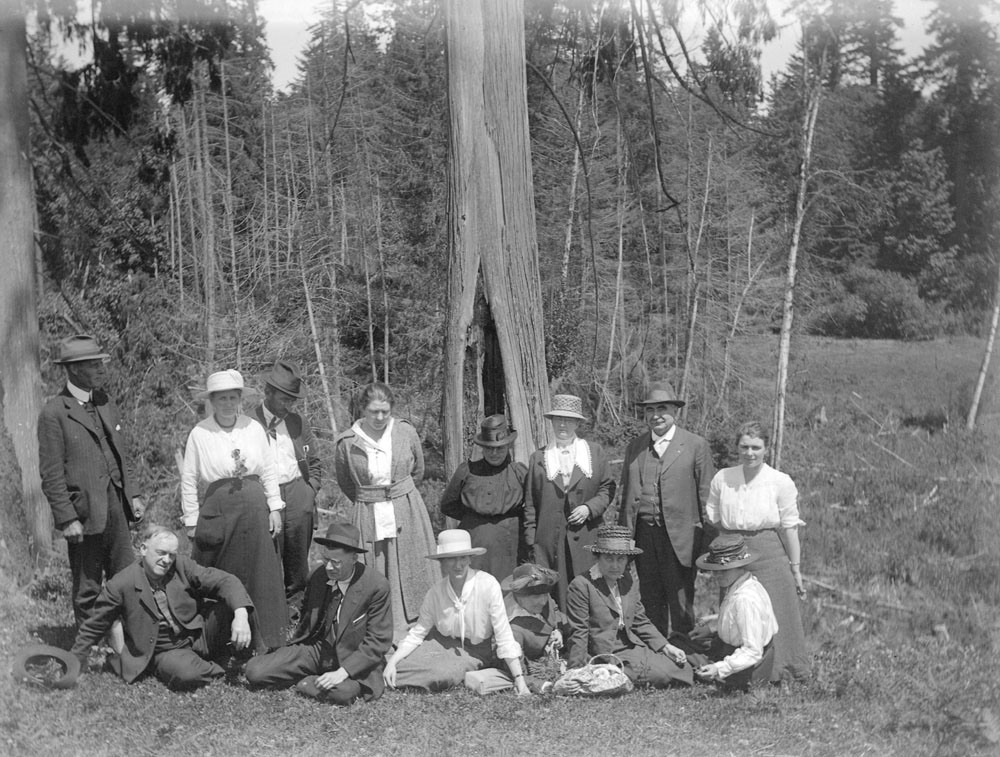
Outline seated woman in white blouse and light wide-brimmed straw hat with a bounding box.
[383,529,531,694]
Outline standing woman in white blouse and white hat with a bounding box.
[181,370,288,651]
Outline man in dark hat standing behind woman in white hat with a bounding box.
[253,360,323,621]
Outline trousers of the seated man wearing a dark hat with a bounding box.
[246,641,363,705]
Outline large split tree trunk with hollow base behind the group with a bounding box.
[442,0,548,475]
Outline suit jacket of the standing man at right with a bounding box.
[618,428,715,567]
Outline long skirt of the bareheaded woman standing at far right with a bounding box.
[735,531,811,681]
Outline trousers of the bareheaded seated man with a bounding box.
[149,602,233,691]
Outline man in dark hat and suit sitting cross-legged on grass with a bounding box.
[246,521,392,705]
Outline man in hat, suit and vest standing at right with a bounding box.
[618,382,715,636]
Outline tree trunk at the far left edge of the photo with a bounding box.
[0,0,46,581]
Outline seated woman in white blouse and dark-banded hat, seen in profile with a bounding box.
[679,534,778,691]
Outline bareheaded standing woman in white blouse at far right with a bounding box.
[706,422,810,681]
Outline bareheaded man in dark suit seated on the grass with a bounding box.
[72,526,253,689]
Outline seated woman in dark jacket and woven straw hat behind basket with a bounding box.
[566,526,693,688]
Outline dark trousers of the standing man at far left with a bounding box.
[66,483,135,629]
